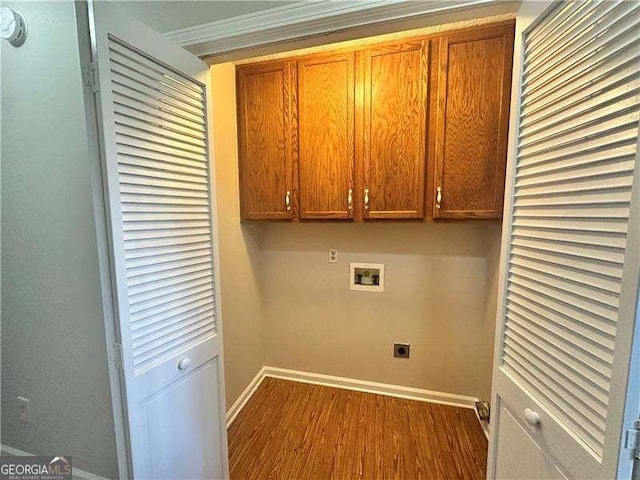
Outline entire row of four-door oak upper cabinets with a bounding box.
[236,22,514,222]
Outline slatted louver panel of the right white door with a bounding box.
[500,2,640,459]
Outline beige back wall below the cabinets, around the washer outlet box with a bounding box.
[261,222,500,399]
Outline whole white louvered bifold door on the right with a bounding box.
[489,1,640,478]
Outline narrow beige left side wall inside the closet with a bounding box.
[211,63,265,408]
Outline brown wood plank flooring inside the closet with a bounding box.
[229,378,487,480]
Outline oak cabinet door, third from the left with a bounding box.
[361,41,427,219]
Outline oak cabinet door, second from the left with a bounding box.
[298,53,355,219]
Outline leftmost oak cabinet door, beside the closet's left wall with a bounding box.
[236,62,295,220]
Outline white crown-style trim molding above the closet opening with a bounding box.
[165,0,500,57]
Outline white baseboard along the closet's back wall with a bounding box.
[263,367,478,409]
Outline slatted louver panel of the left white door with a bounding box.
[109,40,215,374]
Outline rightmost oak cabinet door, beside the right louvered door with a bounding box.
[432,24,513,218]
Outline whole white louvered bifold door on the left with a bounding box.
[89,2,227,479]
